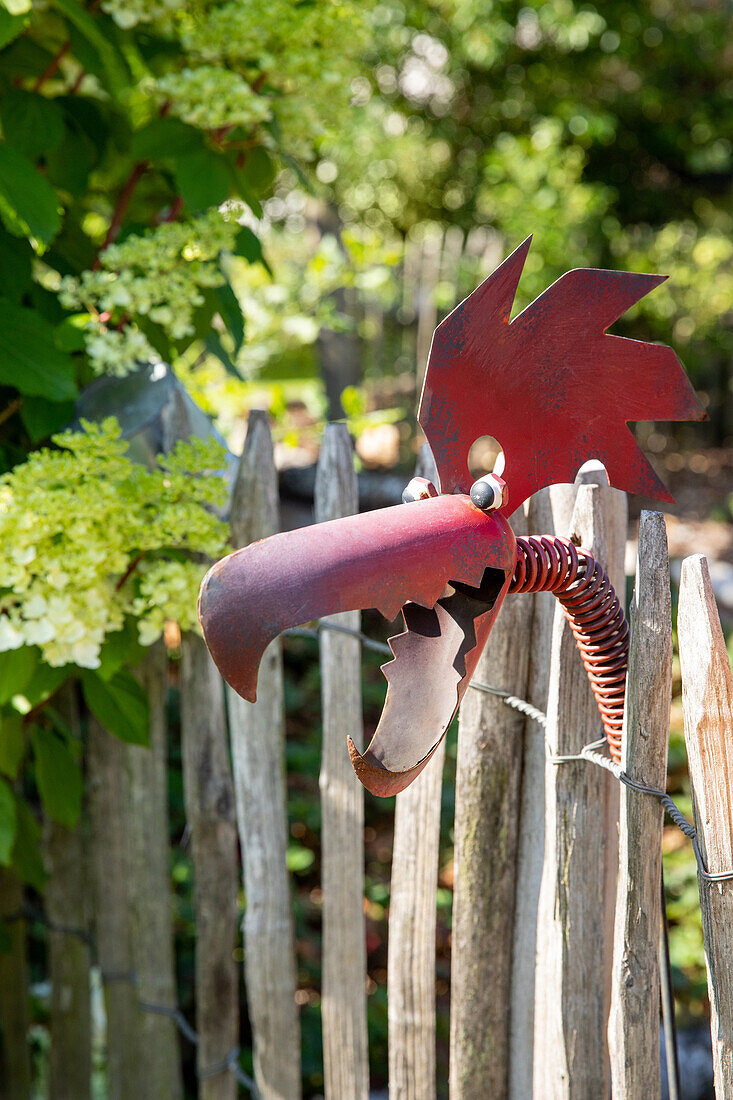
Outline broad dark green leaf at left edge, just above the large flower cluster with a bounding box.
[0,300,77,402]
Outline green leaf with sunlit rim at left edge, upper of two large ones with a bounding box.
[0,143,61,244]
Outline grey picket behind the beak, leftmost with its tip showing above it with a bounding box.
[227,410,300,1100]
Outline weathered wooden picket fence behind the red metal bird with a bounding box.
[0,413,733,1100]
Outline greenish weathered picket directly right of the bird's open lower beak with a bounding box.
[450,510,533,1100]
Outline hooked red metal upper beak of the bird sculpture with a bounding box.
[199,495,515,702]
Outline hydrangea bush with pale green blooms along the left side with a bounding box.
[0,0,362,889]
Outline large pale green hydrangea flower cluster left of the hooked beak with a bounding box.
[0,421,227,669]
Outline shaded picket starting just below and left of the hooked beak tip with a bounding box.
[180,634,239,1100]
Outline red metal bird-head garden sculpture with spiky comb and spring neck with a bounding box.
[199,238,704,795]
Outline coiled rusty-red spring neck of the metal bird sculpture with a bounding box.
[508,535,628,760]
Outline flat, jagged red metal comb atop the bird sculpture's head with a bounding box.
[418,238,704,512]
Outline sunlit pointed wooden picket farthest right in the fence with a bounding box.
[677,554,733,1100]
